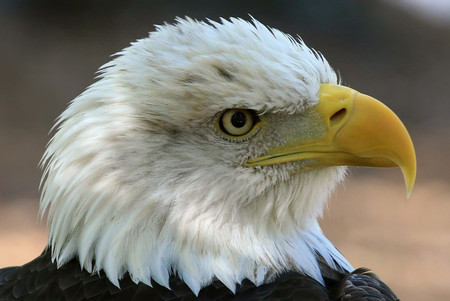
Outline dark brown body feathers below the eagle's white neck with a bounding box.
[0,248,398,301]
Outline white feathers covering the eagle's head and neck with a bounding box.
[41,19,351,293]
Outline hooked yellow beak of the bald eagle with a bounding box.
[245,84,416,197]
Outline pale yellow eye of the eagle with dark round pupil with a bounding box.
[219,109,258,137]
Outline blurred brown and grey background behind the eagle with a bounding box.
[0,0,450,300]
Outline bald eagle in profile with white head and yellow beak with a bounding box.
[0,18,416,300]
